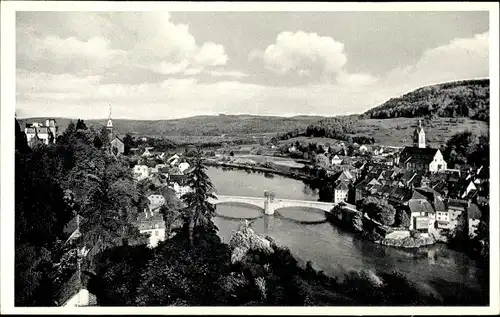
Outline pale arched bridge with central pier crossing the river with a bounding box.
[209,195,336,215]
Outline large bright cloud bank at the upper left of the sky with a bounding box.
[17,12,229,75]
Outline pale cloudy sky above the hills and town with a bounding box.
[16,11,489,120]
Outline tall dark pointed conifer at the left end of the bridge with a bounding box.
[181,152,216,247]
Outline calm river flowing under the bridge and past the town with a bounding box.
[207,167,484,300]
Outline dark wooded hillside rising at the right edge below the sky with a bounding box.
[364,79,490,121]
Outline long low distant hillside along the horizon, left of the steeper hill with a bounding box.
[19,115,323,136]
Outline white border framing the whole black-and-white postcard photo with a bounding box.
[0,1,500,315]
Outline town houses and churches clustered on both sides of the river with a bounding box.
[21,112,489,253]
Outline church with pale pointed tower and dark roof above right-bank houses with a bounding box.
[399,120,447,172]
